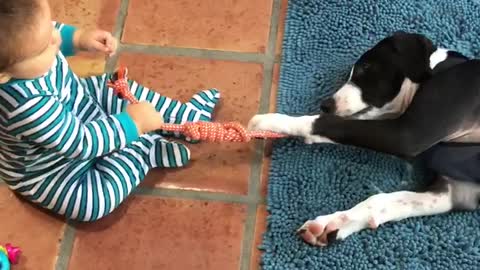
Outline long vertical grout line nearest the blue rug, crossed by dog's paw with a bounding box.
[240,0,281,270]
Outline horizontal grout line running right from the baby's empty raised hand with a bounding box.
[119,43,265,63]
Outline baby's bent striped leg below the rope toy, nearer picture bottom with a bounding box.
[16,134,190,221]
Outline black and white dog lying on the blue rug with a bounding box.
[249,32,480,246]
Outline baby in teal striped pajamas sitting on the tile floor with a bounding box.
[0,0,220,221]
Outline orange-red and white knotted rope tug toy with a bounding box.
[107,67,286,142]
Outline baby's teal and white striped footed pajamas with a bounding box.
[0,21,219,221]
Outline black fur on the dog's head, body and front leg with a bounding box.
[312,33,480,209]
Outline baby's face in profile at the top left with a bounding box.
[2,0,62,82]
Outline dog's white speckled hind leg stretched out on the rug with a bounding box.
[298,177,480,246]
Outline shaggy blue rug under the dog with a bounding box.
[261,0,480,270]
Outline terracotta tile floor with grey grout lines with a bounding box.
[0,0,287,270]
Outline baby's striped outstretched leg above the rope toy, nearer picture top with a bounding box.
[84,75,220,140]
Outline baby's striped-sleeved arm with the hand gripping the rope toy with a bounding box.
[7,96,160,160]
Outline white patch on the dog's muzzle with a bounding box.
[333,82,368,116]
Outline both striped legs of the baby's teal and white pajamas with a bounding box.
[17,75,220,221]
